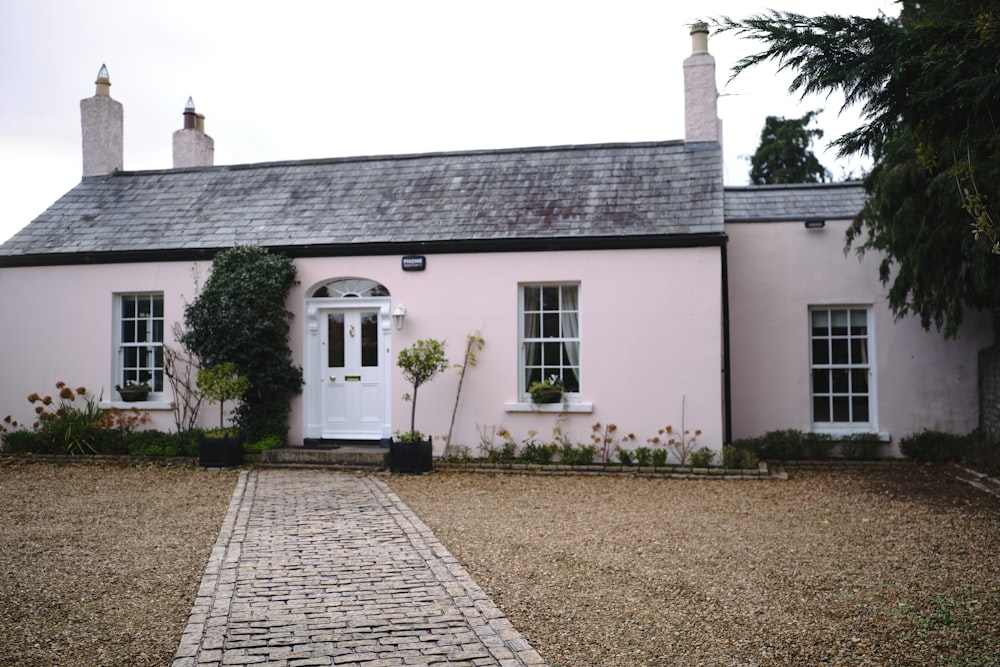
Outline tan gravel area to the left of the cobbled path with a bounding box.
[0,460,238,667]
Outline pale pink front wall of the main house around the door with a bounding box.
[0,248,723,460]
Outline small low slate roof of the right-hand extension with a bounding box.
[725,183,865,222]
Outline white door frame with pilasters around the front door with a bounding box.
[302,296,392,447]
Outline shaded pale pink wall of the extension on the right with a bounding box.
[726,220,992,453]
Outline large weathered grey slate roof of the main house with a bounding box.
[0,142,723,265]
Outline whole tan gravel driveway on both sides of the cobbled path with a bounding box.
[0,461,1000,667]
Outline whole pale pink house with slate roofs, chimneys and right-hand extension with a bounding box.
[0,33,991,460]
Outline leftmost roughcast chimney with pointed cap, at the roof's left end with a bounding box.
[80,65,125,177]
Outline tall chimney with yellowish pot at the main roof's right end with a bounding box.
[684,23,722,144]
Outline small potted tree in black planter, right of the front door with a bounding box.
[389,338,448,472]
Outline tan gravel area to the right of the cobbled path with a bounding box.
[388,464,1000,667]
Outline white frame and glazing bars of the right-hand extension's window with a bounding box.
[807,304,878,436]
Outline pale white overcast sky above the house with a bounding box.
[0,0,898,242]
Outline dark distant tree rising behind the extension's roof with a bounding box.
[750,111,830,185]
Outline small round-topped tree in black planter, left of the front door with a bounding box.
[196,362,250,468]
